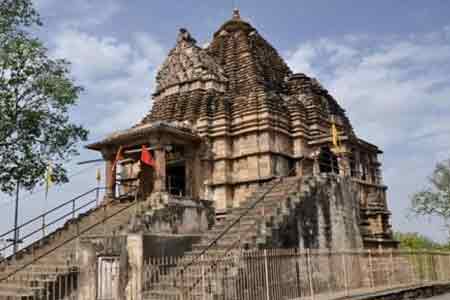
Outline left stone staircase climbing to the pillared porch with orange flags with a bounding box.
[0,197,138,300]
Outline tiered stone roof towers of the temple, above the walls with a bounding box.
[142,11,353,138]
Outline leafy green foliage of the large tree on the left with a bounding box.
[0,0,87,193]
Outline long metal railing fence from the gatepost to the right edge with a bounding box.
[142,249,450,300]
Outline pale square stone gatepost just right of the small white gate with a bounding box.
[126,234,144,300]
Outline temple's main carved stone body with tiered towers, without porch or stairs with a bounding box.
[131,11,389,246]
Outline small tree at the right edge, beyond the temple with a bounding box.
[411,160,450,234]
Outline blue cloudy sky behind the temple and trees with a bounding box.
[0,0,450,244]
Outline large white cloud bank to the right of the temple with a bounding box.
[288,30,450,238]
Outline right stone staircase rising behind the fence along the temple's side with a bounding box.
[143,177,320,300]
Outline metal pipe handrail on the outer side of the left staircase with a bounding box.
[0,187,105,263]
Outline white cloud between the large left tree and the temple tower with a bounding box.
[51,29,165,136]
